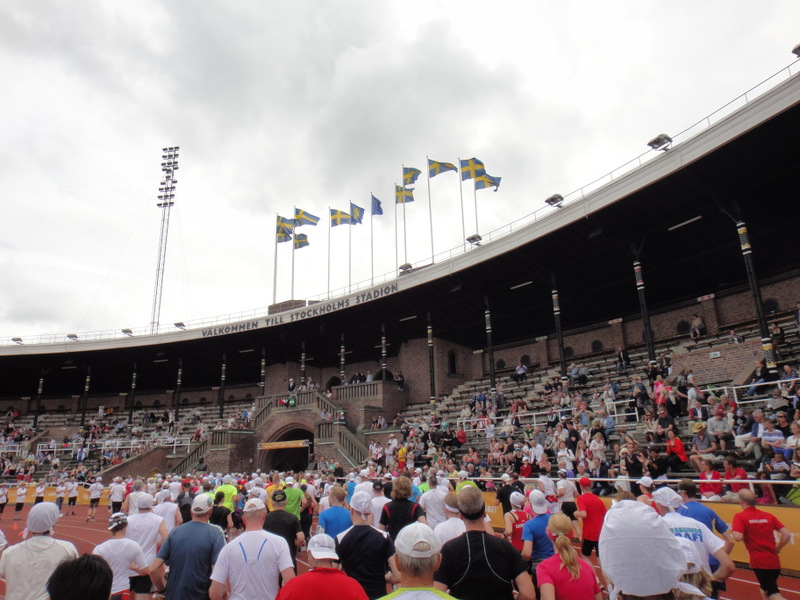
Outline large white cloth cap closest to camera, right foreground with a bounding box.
[599,500,686,596]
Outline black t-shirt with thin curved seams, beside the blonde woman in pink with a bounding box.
[433,531,528,600]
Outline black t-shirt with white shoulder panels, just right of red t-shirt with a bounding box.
[336,525,394,600]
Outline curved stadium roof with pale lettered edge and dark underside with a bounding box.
[0,69,800,397]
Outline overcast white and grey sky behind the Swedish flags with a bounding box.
[0,0,800,343]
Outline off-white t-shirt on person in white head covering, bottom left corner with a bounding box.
[0,535,78,600]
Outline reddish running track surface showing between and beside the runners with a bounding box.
[0,505,800,600]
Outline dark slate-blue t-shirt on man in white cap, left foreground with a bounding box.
[158,521,225,600]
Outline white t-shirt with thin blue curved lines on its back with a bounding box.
[211,531,294,600]
